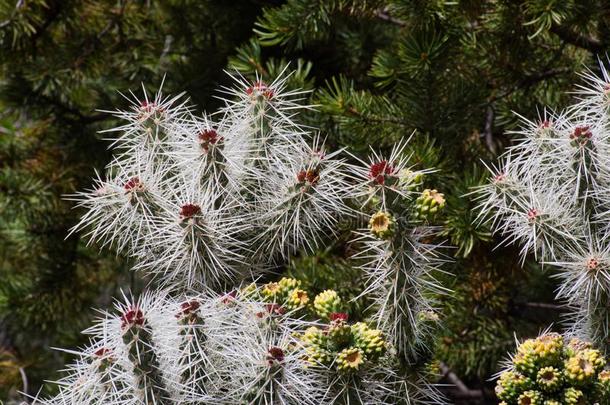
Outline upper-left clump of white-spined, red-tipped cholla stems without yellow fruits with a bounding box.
[73,71,351,288]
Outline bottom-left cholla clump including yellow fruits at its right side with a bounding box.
[39,279,434,405]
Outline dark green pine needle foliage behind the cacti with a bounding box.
[0,0,610,404]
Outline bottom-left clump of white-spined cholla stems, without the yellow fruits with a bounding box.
[40,293,324,405]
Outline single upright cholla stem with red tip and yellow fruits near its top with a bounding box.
[354,144,445,359]
